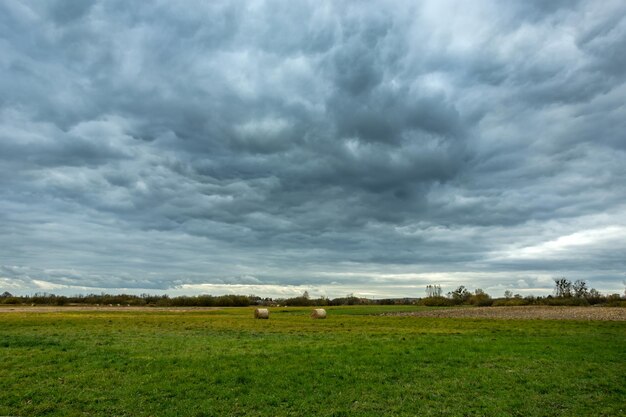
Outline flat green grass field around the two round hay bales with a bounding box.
[0,306,626,416]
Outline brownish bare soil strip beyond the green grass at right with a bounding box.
[384,306,626,321]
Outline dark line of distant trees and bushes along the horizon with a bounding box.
[0,278,626,307]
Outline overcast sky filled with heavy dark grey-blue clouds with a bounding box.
[0,0,626,298]
